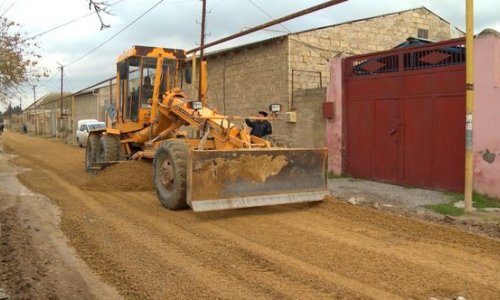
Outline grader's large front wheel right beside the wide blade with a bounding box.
[153,140,189,210]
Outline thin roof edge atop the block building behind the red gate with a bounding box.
[205,6,461,57]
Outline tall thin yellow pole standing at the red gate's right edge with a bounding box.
[464,0,474,212]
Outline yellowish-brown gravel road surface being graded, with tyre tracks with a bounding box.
[2,133,500,299]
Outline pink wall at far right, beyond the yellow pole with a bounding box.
[473,30,500,198]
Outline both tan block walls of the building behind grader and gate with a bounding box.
[202,8,462,141]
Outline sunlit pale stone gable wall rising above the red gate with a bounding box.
[289,8,463,89]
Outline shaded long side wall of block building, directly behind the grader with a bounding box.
[207,40,289,115]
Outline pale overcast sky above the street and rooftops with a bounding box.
[0,0,500,110]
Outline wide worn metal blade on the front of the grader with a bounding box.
[187,149,330,211]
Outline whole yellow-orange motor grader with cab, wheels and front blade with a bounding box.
[85,46,329,211]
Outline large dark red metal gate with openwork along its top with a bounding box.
[344,39,465,191]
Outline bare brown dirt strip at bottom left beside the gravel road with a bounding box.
[0,137,121,299]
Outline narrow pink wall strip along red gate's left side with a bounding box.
[326,55,344,175]
